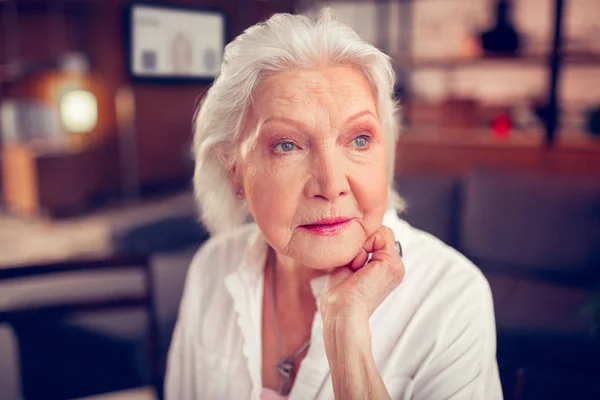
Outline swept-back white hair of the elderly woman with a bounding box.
[193,9,403,233]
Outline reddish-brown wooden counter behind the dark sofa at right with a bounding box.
[396,128,600,179]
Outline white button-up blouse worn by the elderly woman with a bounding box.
[165,211,502,400]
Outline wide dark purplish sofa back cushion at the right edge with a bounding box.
[460,170,600,282]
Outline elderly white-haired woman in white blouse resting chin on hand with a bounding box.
[165,12,502,400]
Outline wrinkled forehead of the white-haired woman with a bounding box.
[252,66,377,119]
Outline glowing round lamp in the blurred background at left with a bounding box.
[60,90,98,133]
